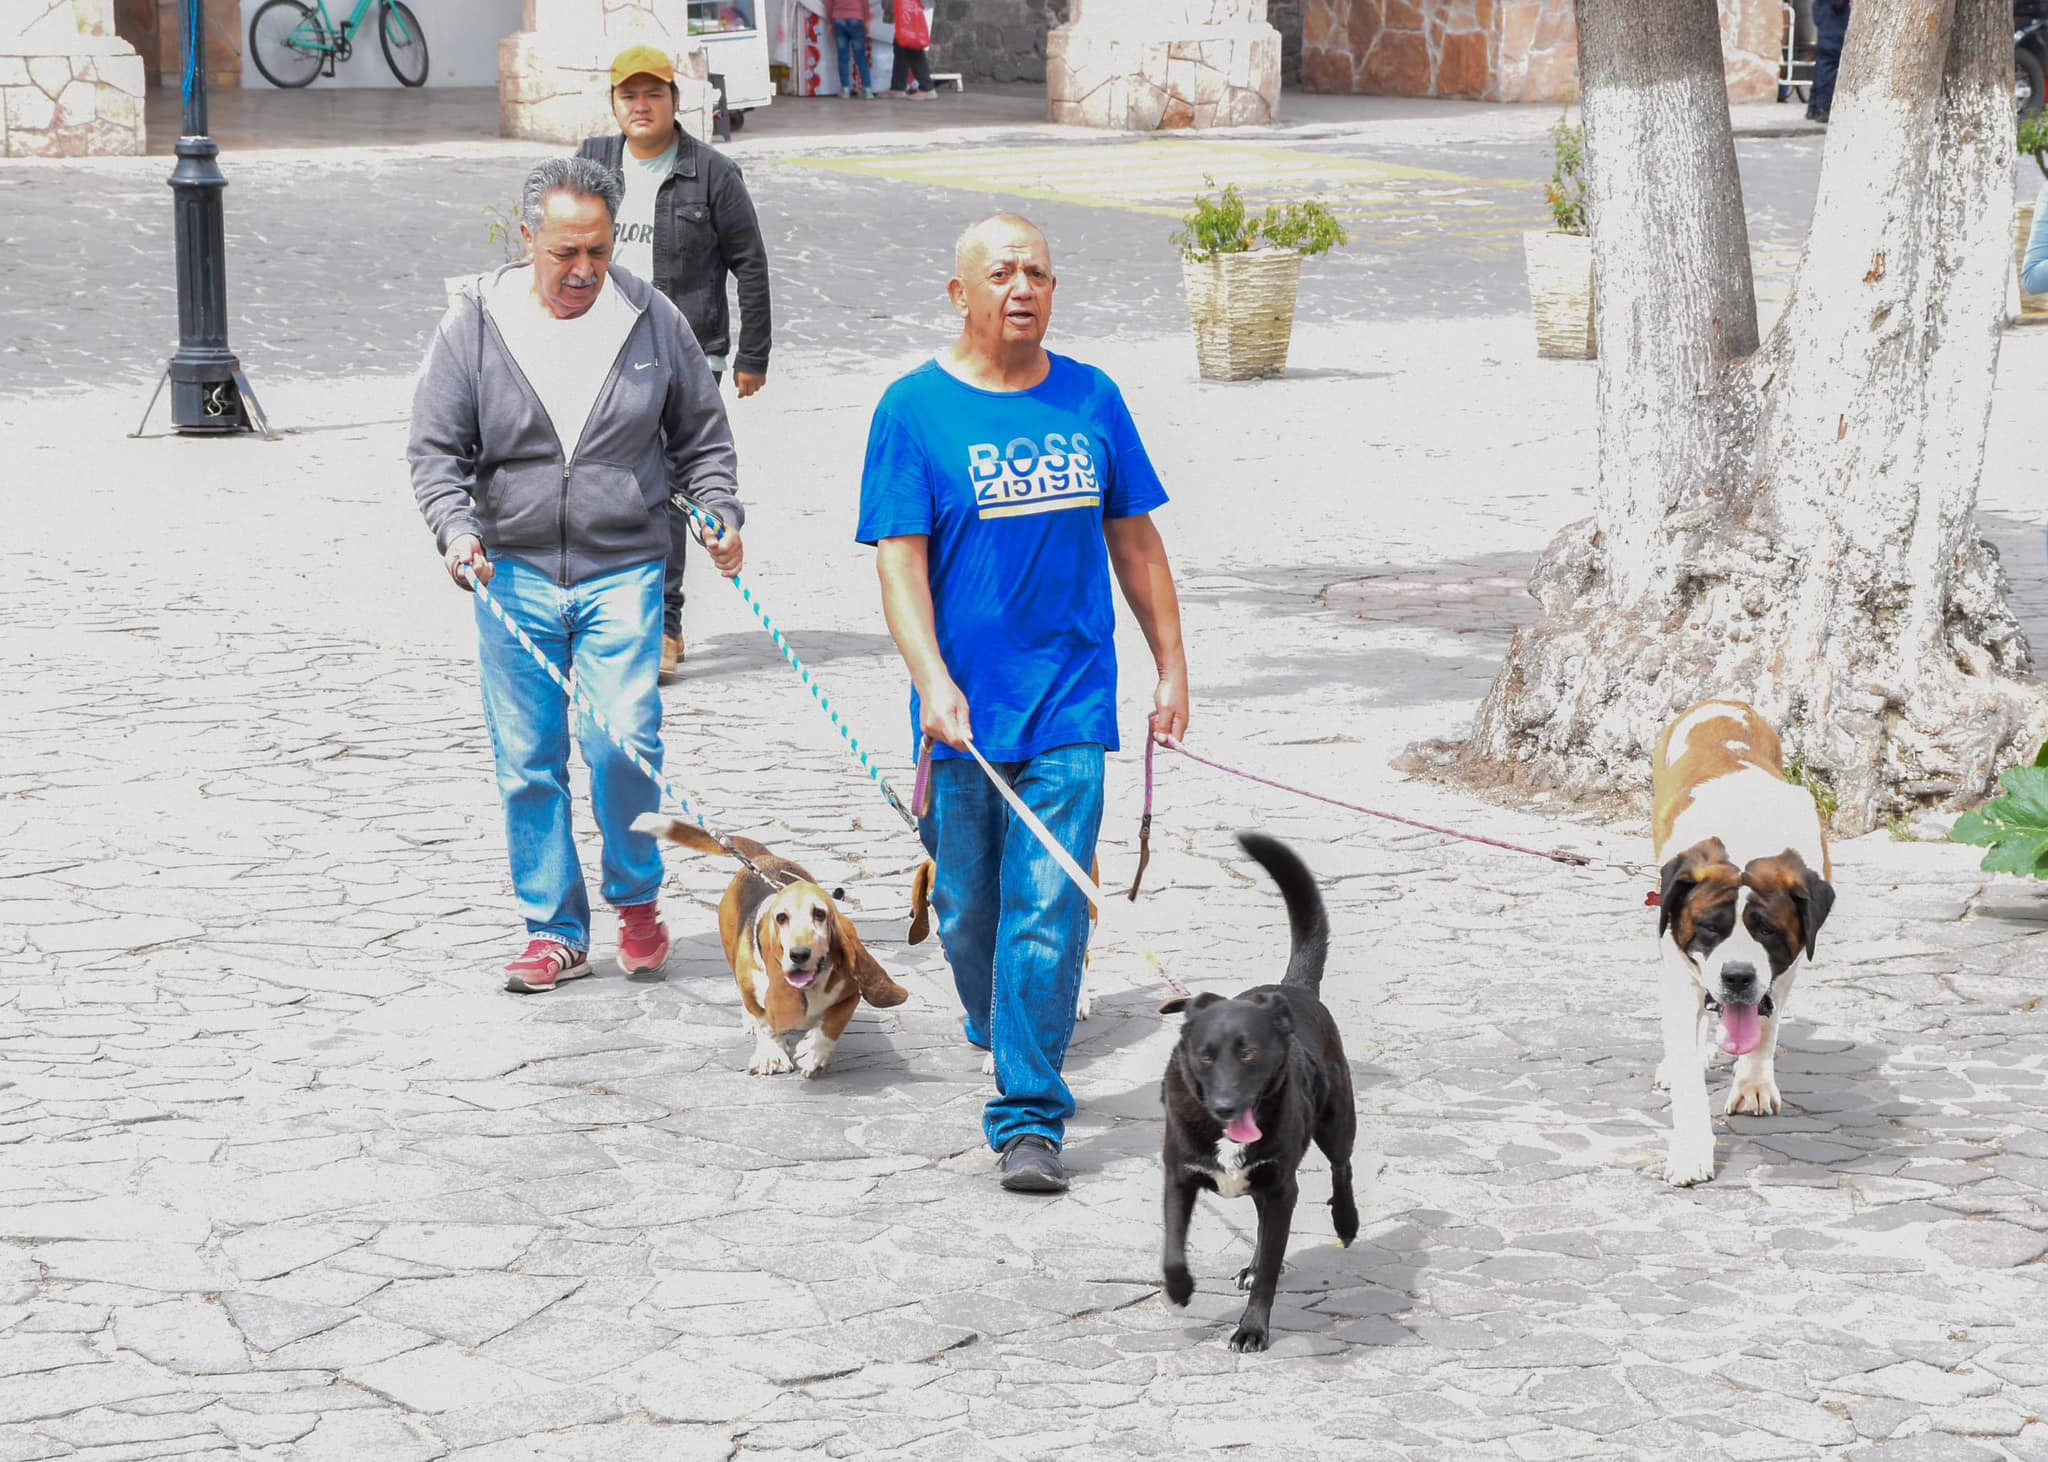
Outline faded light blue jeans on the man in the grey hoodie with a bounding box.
[477,559,662,950]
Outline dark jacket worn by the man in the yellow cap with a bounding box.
[578,125,770,375]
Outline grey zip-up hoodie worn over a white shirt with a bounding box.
[406,264,745,586]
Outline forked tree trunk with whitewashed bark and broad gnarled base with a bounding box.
[1458,0,2048,835]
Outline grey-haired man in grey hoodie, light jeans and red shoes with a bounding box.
[408,158,743,993]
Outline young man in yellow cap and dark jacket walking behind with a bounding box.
[578,45,770,684]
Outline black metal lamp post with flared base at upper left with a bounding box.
[135,0,270,436]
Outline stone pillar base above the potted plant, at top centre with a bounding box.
[1044,0,1280,131]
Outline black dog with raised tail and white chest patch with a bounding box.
[1159,833,1358,1349]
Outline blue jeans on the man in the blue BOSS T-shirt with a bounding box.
[918,741,1104,1151]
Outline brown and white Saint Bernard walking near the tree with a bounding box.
[1651,700,1835,1188]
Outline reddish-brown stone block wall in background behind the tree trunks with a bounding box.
[1300,0,1784,102]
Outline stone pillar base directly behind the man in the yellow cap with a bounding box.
[498,0,717,145]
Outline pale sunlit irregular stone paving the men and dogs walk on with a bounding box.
[0,131,2048,1462]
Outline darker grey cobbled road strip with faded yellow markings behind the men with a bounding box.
[0,126,1859,393]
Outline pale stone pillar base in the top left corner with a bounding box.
[0,0,147,158]
